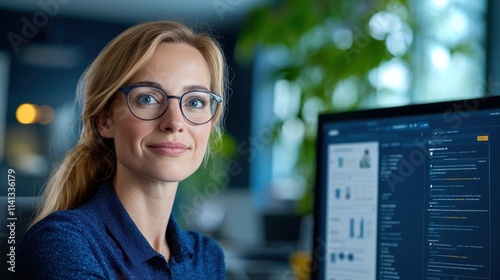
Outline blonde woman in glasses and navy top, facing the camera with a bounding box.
[16,21,226,279]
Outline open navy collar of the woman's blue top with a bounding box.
[89,182,193,263]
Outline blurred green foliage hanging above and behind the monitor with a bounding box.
[235,0,413,214]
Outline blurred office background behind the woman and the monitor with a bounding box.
[0,0,500,279]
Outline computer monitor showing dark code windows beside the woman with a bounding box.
[311,96,500,280]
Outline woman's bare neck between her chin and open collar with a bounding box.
[113,166,178,260]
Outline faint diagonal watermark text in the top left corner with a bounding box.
[7,0,69,54]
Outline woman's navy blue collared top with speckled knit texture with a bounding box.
[15,183,225,279]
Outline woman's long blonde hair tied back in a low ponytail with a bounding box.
[31,21,227,225]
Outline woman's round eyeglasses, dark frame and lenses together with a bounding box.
[119,85,222,124]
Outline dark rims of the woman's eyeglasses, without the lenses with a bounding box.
[118,85,223,125]
